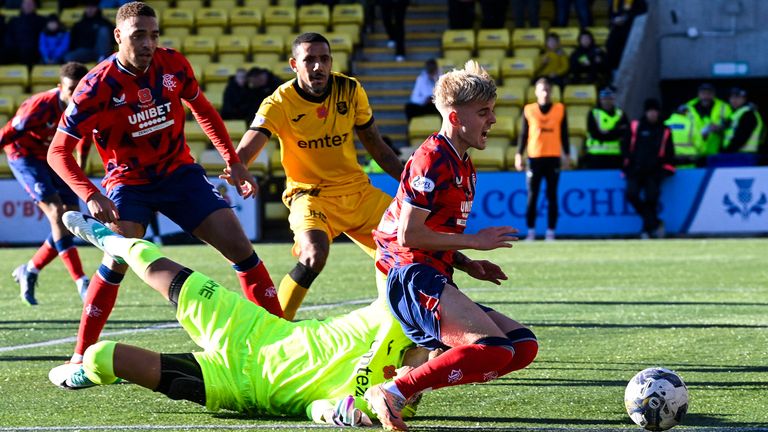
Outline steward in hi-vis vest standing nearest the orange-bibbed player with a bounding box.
[584,87,629,169]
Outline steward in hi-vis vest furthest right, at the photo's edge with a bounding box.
[723,87,763,153]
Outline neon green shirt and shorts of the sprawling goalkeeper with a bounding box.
[184,287,414,418]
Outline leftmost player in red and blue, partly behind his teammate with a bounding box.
[0,62,88,305]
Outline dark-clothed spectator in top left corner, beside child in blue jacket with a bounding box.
[3,0,45,66]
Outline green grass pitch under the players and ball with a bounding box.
[0,239,768,431]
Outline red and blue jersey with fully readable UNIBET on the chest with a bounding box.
[58,48,201,190]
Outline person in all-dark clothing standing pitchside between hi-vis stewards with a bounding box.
[622,99,675,239]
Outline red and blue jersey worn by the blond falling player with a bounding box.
[373,134,477,278]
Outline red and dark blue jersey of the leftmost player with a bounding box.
[0,88,64,160]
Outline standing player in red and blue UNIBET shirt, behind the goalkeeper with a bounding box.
[48,2,281,386]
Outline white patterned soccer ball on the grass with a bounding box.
[624,367,688,431]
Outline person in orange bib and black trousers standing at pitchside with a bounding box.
[515,78,571,241]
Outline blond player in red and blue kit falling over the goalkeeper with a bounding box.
[365,61,538,430]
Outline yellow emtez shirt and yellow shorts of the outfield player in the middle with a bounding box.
[251,72,392,257]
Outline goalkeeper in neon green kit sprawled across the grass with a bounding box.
[49,212,429,426]
